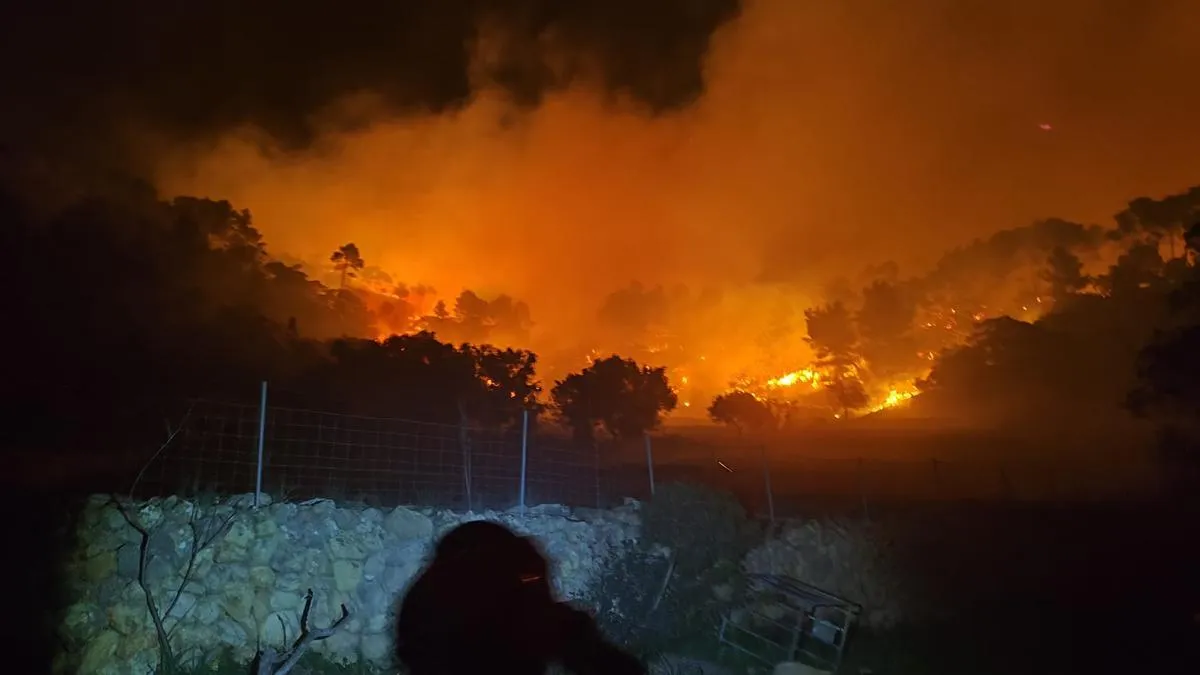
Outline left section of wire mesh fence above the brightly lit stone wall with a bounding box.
[136,401,602,509]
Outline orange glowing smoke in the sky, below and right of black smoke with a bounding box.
[158,0,1200,357]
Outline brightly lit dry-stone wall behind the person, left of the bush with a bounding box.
[58,497,640,675]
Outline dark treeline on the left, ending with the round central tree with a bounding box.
[0,185,674,449]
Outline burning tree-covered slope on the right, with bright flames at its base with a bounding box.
[709,187,1200,456]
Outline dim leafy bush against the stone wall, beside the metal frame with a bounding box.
[589,484,761,659]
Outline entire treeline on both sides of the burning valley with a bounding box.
[0,176,1200,466]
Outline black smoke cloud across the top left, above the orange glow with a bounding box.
[0,0,740,156]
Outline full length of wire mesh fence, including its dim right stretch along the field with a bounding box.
[121,391,1160,518]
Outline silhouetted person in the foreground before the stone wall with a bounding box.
[396,521,646,675]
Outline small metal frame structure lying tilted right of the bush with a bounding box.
[718,574,862,673]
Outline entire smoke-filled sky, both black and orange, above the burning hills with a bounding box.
[5,0,1200,384]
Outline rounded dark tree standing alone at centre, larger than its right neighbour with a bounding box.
[550,354,678,440]
